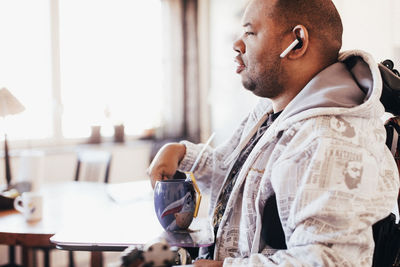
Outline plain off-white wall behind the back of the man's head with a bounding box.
[333,0,400,62]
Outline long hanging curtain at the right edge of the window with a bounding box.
[162,0,200,142]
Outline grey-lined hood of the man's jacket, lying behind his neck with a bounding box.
[254,50,384,132]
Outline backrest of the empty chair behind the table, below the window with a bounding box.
[75,149,112,183]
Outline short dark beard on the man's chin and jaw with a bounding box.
[242,55,285,98]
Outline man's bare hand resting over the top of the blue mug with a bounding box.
[147,143,186,188]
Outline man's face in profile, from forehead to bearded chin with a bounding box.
[234,0,285,99]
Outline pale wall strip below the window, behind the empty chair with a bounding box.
[0,141,152,185]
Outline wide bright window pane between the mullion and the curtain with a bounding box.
[59,0,162,137]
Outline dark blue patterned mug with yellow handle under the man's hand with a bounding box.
[154,173,201,231]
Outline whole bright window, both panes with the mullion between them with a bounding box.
[0,0,163,142]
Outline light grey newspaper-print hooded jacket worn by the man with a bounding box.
[179,51,399,266]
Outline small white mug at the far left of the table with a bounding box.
[14,192,43,222]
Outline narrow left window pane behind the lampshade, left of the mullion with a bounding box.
[0,0,53,139]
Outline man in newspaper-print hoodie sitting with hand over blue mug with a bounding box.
[149,0,399,266]
